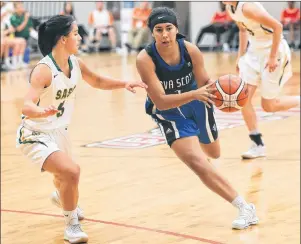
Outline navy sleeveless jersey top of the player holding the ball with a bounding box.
[145,39,197,114]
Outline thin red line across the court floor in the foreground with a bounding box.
[1,209,225,244]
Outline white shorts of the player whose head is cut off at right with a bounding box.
[238,40,292,99]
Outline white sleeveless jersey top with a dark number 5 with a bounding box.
[22,53,82,131]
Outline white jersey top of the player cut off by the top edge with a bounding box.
[226,2,283,50]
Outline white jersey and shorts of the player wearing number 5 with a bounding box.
[16,54,82,169]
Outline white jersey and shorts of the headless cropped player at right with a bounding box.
[227,2,292,99]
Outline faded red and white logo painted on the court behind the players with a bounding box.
[84,108,300,149]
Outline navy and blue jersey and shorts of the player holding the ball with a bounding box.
[145,39,218,146]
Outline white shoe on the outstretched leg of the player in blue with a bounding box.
[232,203,259,230]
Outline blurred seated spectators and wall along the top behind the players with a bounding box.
[1,1,300,71]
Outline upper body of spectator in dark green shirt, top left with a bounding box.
[10,2,37,41]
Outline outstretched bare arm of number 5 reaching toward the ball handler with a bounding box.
[78,59,147,93]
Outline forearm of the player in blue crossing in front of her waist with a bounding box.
[155,91,195,110]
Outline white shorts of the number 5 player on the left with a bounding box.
[16,124,72,171]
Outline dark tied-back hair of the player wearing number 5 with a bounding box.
[38,15,74,56]
